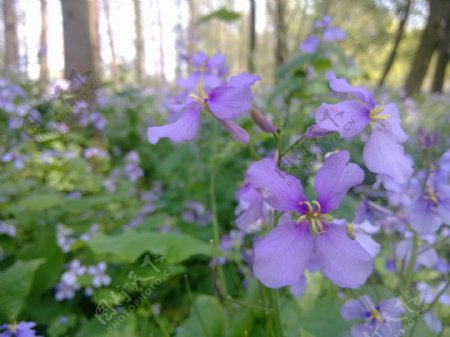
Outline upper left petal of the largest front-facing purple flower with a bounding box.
[247,158,306,212]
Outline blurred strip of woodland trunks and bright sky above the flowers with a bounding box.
[0,0,450,92]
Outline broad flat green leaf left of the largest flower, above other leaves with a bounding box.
[86,231,211,263]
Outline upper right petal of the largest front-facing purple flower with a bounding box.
[314,150,364,213]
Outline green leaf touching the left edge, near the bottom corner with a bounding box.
[0,259,44,323]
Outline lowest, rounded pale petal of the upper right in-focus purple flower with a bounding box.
[363,128,413,184]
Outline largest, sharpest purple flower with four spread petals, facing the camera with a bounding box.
[247,151,373,288]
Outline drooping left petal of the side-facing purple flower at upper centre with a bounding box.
[147,103,201,144]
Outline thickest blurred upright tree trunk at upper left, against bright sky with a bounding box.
[61,0,101,81]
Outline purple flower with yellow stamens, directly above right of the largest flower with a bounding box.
[316,71,413,183]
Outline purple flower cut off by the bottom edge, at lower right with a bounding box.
[341,295,405,337]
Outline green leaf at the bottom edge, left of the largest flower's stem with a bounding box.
[176,295,225,337]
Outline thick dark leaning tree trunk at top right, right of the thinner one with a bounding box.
[405,0,450,95]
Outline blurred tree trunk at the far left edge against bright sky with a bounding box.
[3,0,19,70]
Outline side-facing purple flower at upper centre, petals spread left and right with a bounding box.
[147,73,260,144]
